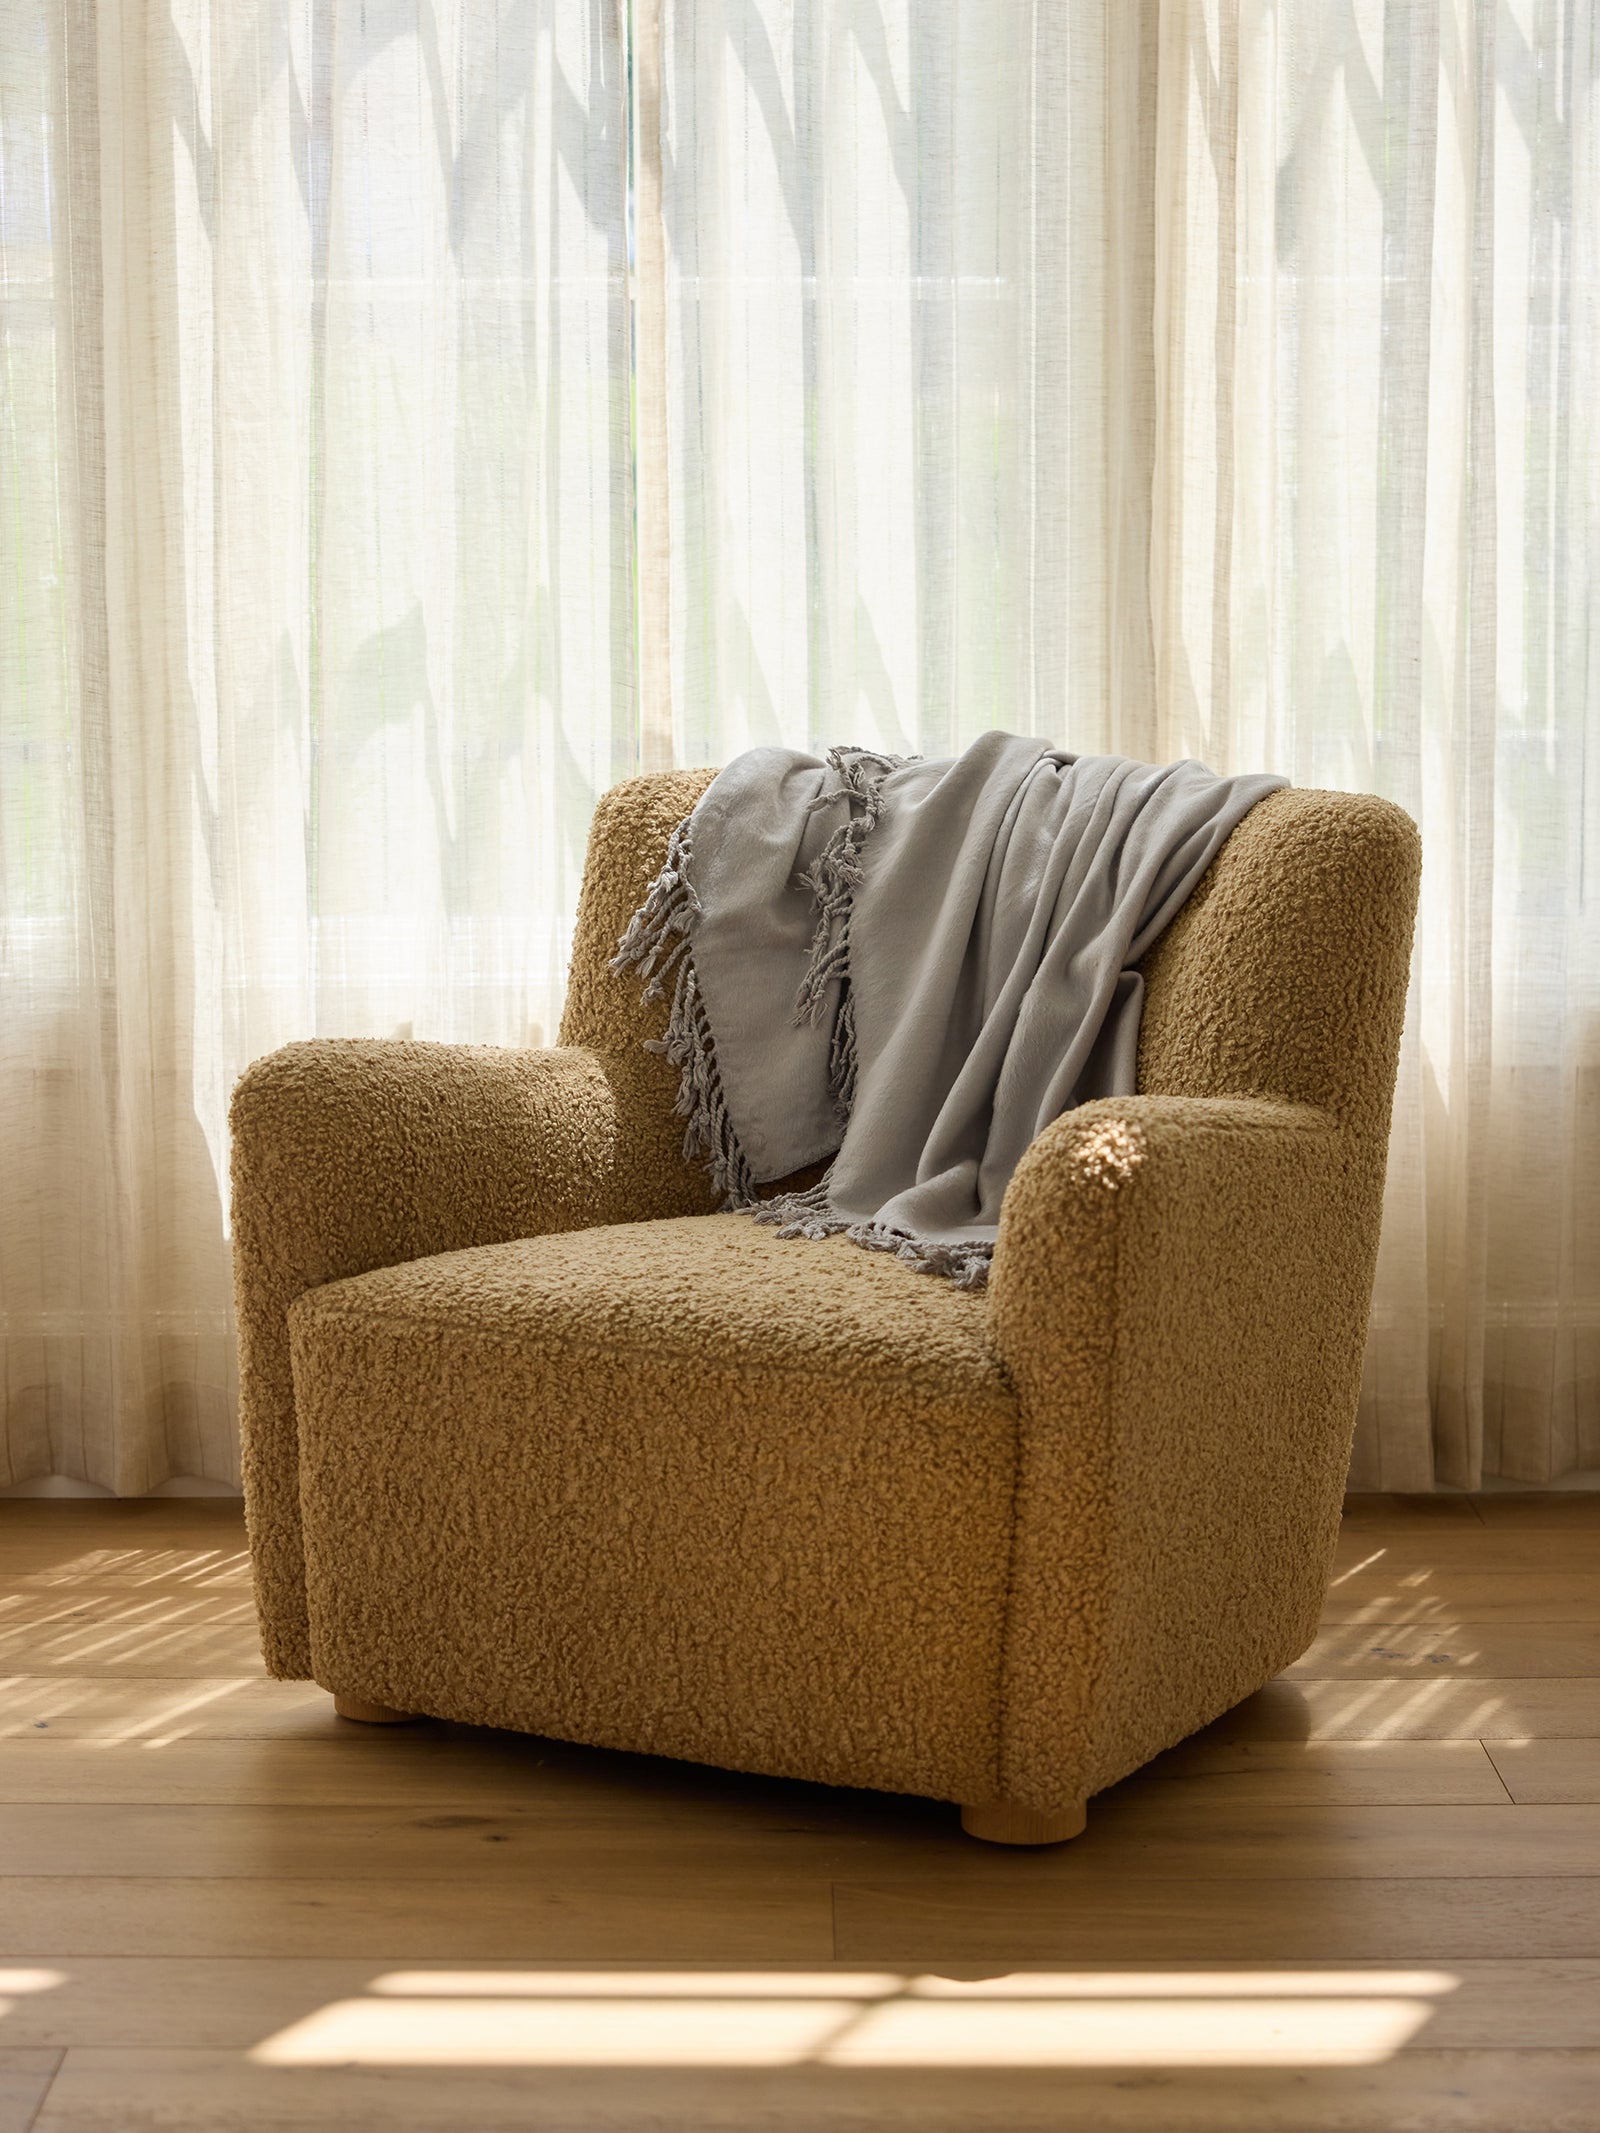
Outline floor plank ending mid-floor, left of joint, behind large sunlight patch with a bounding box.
[0,1885,827,1964]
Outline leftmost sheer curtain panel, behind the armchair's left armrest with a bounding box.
[0,0,636,1493]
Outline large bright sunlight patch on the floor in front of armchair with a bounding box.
[252,1971,1457,2067]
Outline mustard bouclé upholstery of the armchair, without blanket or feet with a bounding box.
[235,772,1419,1813]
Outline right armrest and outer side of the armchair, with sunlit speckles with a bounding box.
[990,1096,1382,1809]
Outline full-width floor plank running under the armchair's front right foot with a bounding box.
[0,1787,1600,1903]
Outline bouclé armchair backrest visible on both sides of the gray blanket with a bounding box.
[561,770,1421,1177]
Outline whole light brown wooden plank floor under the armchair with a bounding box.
[0,1495,1600,2133]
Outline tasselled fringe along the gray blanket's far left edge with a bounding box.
[610,815,755,1209]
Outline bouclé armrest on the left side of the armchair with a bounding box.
[233,1041,708,1679]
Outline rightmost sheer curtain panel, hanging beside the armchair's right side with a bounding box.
[1152,0,1600,1489]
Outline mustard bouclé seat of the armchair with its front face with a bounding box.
[290,1216,1015,1798]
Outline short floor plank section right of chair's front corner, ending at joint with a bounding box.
[1117,1734,1506,1815]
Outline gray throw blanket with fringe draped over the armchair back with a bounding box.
[612,734,1284,1288]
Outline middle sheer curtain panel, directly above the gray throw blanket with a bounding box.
[663,0,1158,761]
